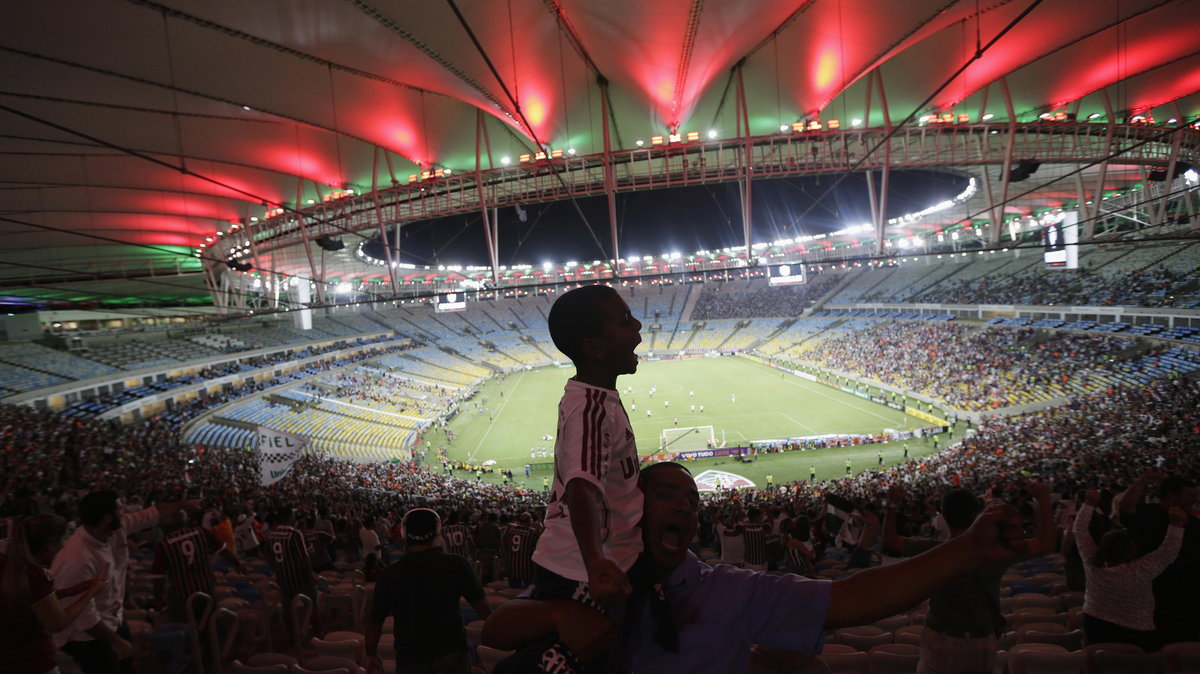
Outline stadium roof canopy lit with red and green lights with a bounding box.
[0,0,1200,306]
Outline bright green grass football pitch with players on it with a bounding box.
[427,357,959,488]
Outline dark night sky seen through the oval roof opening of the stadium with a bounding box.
[366,170,967,265]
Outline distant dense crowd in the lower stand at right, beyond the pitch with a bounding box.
[798,321,1152,411]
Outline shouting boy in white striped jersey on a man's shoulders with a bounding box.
[532,285,642,661]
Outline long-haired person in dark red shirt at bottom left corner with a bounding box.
[0,514,108,674]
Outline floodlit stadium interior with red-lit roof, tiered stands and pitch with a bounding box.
[0,0,1200,673]
